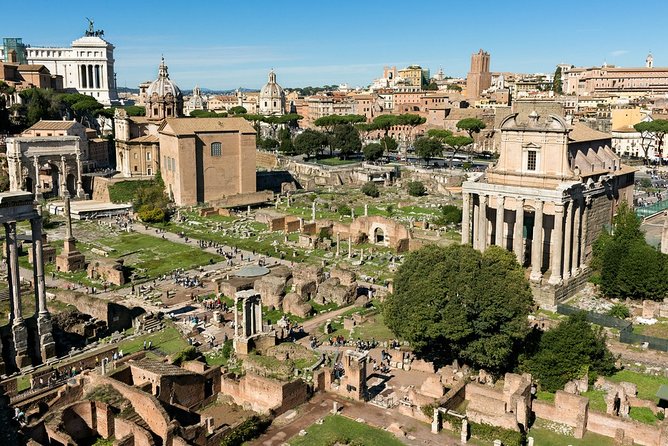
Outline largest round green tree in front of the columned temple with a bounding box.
[384,245,533,374]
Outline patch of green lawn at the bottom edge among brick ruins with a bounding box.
[289,415,402,446]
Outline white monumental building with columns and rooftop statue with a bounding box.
[0,21,118,105]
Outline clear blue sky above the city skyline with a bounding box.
[0,0,668,89]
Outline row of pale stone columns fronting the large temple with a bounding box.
[462,193,589,284]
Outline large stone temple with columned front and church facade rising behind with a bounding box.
[462,112,634,307]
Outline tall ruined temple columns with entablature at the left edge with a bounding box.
[0,192,56,374]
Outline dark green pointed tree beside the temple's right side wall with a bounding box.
[592,202,668,300]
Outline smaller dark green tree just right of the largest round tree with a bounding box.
[521,312,615,392]
